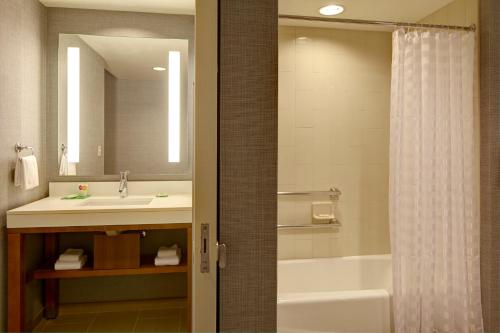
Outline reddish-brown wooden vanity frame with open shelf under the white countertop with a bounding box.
[7,223,192,332]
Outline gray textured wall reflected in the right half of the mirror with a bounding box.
[104,76,169,175]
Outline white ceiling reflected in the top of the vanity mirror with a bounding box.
[76,35,188,81]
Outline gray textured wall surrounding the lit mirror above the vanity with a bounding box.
[47,8,194,181]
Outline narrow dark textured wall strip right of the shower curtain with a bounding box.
[480,0,500,332]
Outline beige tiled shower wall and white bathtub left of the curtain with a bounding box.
[278,26,392,332]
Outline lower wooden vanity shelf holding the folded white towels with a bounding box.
[33,256,188,280]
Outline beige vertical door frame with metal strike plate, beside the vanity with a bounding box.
[191,0,218,332]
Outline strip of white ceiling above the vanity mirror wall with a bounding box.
[39,0,195,15]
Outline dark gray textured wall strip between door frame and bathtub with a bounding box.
[219,0,278,332]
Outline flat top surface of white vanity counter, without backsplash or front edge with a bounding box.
[7,194,192,215]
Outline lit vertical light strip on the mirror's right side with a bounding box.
[168,51,181,163]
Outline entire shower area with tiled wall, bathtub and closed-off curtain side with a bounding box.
[278,0,482,333]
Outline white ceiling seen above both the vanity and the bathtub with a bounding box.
[40,0,453,22]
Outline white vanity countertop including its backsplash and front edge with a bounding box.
[7,181,192,228]
